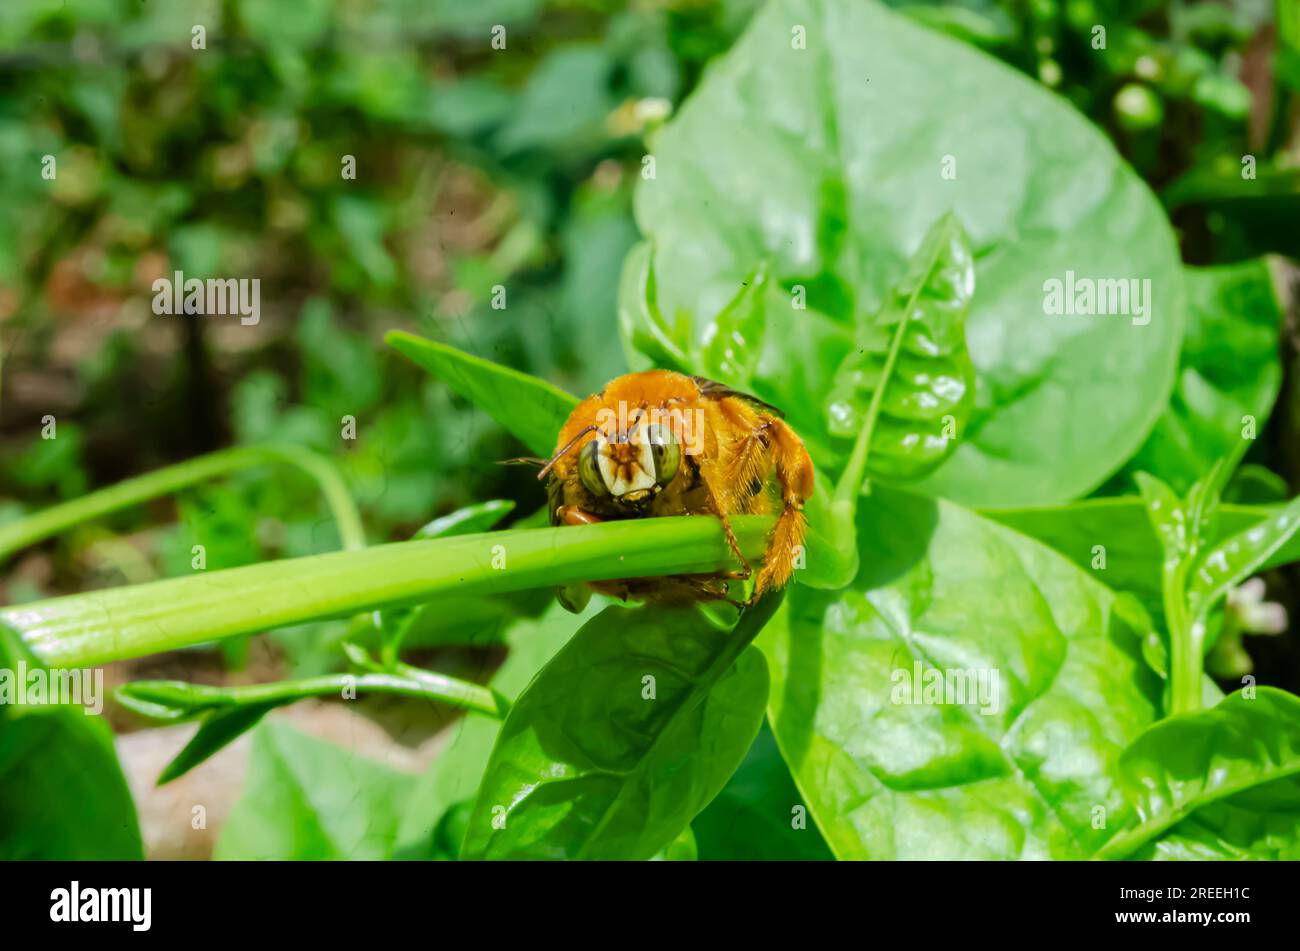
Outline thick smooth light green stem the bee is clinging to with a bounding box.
[0,516,772,666]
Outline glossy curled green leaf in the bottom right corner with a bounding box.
[1104,687,1300,859]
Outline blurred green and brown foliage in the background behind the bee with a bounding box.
[0,0,1300,685]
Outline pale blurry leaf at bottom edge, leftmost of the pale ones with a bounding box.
[213,720,415,860]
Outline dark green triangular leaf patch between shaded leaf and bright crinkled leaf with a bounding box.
[690,722,835,861]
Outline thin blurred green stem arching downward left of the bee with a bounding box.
[0,446,365,561]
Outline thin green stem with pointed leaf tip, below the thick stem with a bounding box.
[120,668,508,720]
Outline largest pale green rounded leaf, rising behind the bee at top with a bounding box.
[620,0,1184,505]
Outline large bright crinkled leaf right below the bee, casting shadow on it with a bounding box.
[758,488,1160,859]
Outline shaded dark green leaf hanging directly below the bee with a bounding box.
[463,596,779,859]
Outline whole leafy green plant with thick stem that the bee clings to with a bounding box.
[0,0,1300,859]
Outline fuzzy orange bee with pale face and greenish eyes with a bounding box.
[538,370,813,608]
